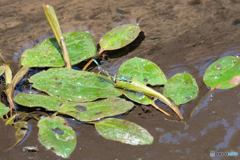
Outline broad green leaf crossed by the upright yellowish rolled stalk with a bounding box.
[21,31,97,67]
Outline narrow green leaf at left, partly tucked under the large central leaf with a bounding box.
[13,93,67,111]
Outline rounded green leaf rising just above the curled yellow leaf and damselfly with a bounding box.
[117,57,167,86]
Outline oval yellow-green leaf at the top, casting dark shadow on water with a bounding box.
[100,24,140,50]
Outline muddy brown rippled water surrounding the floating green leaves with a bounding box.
[0,0,240,160]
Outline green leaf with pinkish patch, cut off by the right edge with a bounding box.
[203,56,240,89]
